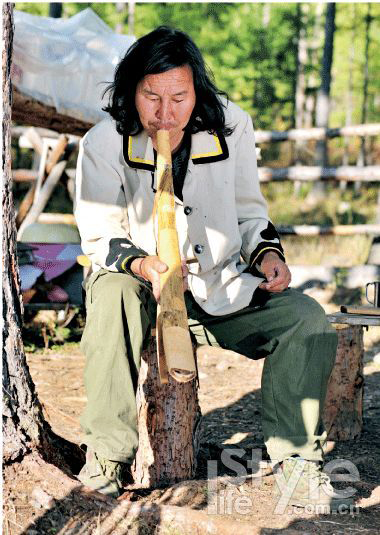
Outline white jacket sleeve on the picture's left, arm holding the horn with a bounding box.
[75,136,147,273]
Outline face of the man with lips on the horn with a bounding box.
[135,65,195,151]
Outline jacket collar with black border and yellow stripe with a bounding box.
[123,130,229,171]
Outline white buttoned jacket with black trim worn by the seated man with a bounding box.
[75,103,283,315]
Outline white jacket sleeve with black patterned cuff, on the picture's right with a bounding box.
[235,114,285,275]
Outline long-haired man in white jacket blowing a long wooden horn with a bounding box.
[75,27,350,505]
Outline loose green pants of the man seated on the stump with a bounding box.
[81,270,337,462]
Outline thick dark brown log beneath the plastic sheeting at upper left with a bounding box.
[12,87,93,136]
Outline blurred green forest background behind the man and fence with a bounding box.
[15,2,380,237]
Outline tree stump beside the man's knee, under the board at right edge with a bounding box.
[323,325,364,440]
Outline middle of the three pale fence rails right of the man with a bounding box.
[258,165,380,182]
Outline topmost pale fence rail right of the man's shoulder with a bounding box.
[255,123,380,143]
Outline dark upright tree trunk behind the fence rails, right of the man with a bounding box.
[312,2,336,199]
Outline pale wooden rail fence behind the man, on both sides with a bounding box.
[12,119,380,236]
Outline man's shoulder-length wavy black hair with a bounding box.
[103,26,233,136]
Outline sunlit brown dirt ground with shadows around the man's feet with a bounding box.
[3,296,380,535]
